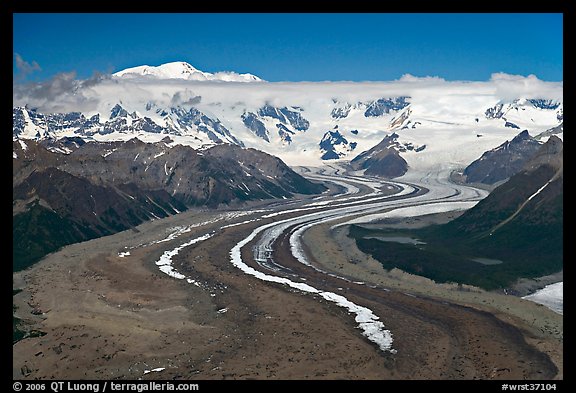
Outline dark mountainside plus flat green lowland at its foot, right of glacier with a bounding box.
[350,136,564,289]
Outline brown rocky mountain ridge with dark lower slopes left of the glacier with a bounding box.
[12,139,324,270]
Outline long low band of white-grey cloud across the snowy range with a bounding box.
[13,73,563,116]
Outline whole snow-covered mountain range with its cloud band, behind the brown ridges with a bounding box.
[13,68,563,169]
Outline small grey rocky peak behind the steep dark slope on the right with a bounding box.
[464,130,541,184]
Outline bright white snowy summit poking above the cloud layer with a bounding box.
[113,61,263,82]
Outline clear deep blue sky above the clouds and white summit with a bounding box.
[13,14,563,81]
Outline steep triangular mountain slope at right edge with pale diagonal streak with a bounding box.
[446,136,564,276]
